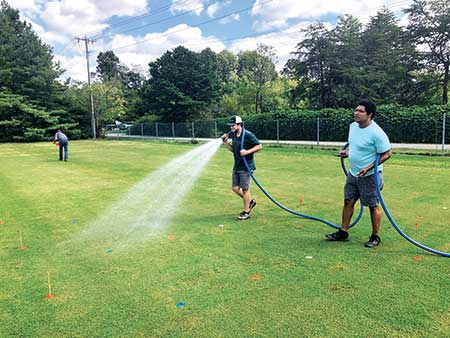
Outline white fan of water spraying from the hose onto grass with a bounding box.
[78,138,221,248]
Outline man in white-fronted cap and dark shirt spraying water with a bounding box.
[222,116,262,221]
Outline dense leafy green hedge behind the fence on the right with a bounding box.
[217,105,450,143]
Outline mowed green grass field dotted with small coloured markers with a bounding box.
[0,141,450,337]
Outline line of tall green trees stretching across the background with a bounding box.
[0,0,450,141]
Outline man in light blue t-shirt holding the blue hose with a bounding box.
[325,100,392,248]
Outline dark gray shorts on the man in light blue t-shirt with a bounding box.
[344,172,384,207]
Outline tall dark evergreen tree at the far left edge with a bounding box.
[0,1,73,141]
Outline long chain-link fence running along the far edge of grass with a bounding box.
[107,114,450,153]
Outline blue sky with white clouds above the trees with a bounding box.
[8,0,412,81]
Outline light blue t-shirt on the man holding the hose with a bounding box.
[348,121,391,176]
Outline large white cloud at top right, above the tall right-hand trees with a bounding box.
[251,0,411,31]
